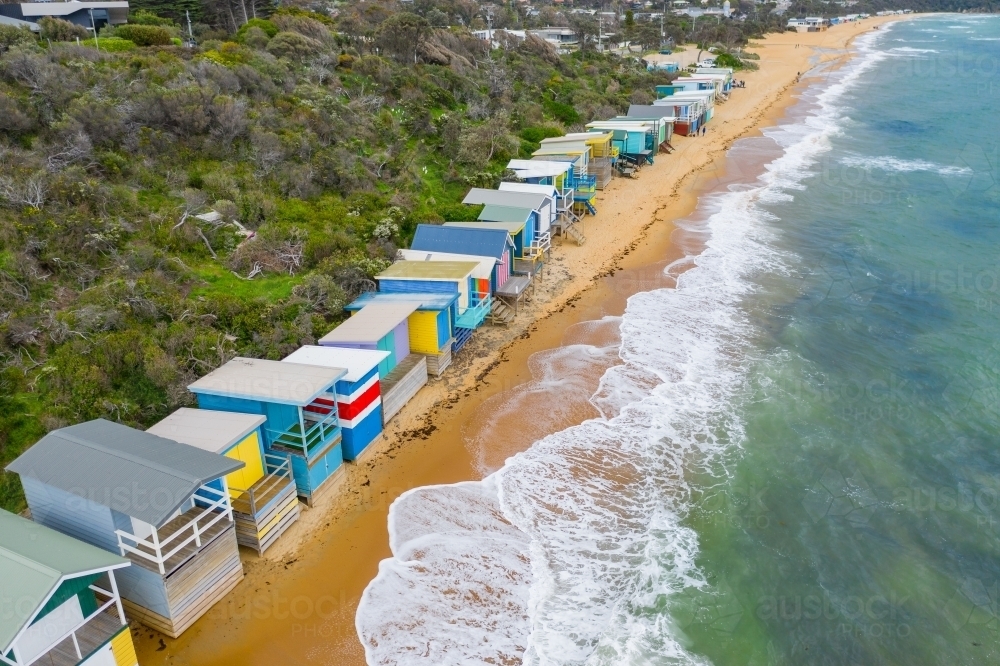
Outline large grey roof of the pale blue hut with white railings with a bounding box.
[7,419,243,527]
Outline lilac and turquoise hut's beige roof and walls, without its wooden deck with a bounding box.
[319,303,417,377]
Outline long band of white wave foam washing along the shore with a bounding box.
[356,20,900,666]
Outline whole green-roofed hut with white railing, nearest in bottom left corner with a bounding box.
[0,509,138,666]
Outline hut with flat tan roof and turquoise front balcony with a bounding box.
[372,262,493,351]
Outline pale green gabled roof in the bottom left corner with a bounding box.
[0,509,129,654]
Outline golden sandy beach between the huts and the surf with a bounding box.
[132,15,912,665]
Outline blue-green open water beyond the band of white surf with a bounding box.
[670,17,1000,665]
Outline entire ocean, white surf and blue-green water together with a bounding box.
[356,15,1000,666]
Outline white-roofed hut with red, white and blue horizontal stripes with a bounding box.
[283,345,390,460]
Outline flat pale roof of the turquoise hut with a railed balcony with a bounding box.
[188,357,346,407]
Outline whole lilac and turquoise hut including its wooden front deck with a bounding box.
[319,304,427,412]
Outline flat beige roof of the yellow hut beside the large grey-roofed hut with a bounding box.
[146,407,267,453]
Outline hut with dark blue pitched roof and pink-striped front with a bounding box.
[410,223,516,290]
